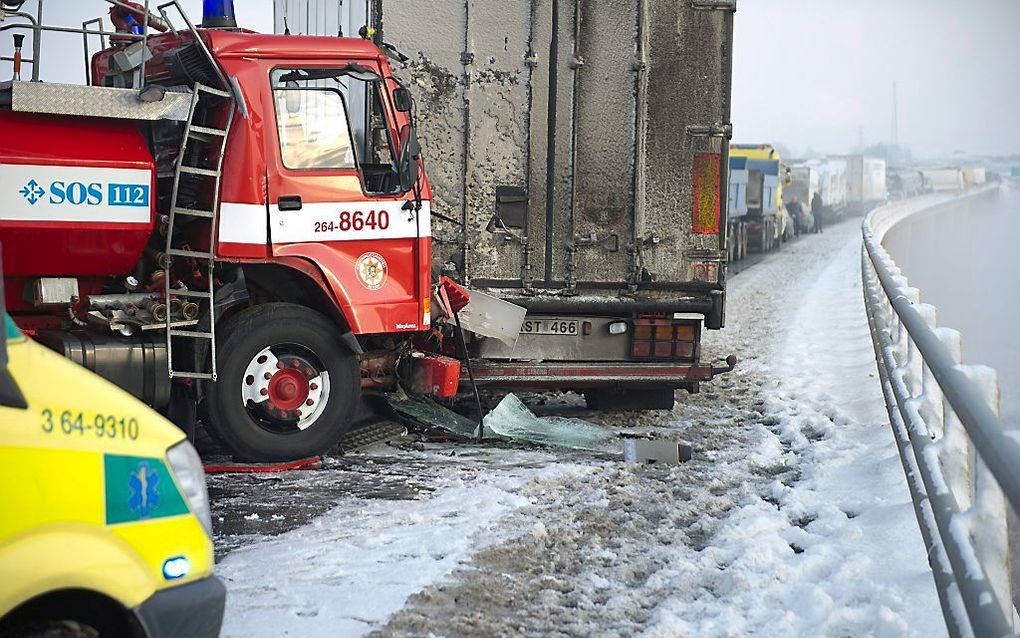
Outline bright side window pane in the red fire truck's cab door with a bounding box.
[272,82,355,169]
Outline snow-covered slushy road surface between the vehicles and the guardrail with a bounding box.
[212,219,945,637]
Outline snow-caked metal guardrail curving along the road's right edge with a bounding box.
[861,189,1020,637]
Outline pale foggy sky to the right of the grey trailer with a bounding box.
[732,0,1020,156]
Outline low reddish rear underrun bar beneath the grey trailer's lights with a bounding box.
[461,355,736,390]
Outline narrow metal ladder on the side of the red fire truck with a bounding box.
[162,83,235,381]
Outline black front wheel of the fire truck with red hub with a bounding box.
[204,303,361,461]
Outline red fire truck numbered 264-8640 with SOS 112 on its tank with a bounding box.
[0,0,725,460]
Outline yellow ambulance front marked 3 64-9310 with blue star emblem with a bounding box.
[0,316,225,638]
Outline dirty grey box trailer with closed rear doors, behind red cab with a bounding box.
[276,0,735,404]
